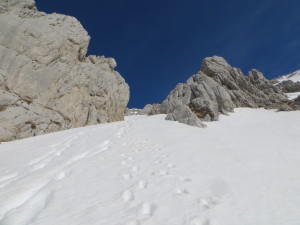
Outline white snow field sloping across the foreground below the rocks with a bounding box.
[0,108,300,225]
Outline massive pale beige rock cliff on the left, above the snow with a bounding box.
[0,0,129,141]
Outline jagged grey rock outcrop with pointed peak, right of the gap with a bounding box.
[161,56,291,127]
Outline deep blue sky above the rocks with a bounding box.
[36,0,300,108]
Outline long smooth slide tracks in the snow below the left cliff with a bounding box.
[0,128,111,225]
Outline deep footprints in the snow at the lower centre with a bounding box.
[121,135,220,225]
